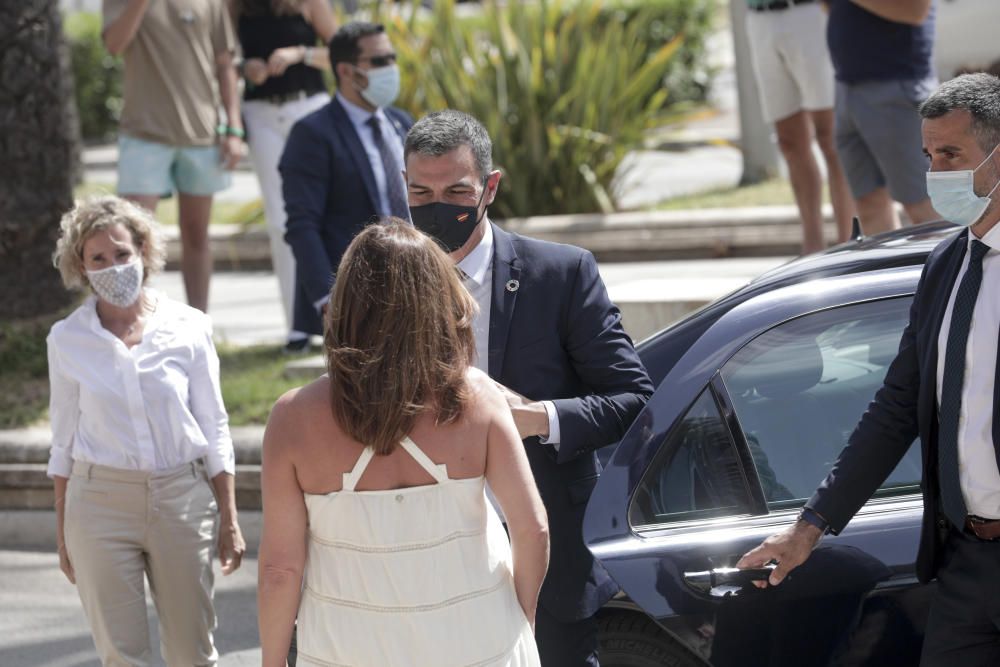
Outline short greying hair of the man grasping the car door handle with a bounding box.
[920,72,1000,152]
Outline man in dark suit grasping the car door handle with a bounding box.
[739,74,1000,666]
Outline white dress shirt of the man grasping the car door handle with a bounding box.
[937,225,1000,519]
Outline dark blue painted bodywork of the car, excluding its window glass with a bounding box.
[584,224,955,666]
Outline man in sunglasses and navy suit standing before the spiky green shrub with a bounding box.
[278,21,413,340]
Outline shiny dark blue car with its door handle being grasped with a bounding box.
[584,223,955,667]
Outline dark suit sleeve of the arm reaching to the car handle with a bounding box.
[806,266,935,534]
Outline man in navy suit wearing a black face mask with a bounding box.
[405,111,653,667]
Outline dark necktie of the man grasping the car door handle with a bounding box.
[938,241,989,530]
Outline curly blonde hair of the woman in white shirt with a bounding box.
[52,195,167,289]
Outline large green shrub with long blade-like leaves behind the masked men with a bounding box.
[384,0,712,217]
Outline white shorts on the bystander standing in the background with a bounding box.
[747,2,834,123]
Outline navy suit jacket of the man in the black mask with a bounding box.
[488,225,653,622]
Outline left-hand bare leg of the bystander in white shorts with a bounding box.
[775,111,826,254]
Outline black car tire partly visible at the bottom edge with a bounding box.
[597,612,706,667]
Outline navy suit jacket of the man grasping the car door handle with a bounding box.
[806,230,1000,582]
